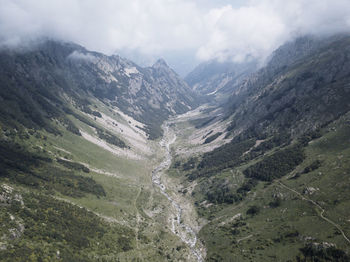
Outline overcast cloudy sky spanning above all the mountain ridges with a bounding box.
[0,0,350,73]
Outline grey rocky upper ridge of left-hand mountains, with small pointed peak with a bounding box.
[0,41,197,138]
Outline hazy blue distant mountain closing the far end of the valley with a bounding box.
[185,59,258,99]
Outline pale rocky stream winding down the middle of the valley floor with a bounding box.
[152,122,203,262]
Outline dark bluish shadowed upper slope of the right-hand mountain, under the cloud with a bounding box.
[223,36,350,139]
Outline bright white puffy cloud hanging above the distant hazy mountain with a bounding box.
[197,6,286,62]
